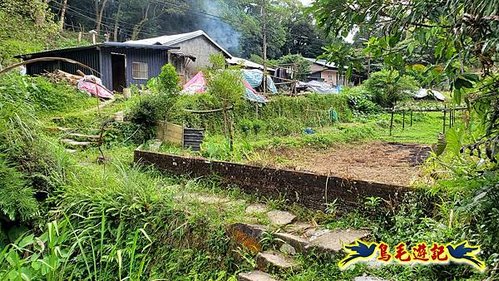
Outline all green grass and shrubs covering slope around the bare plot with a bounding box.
[0,0,499,281]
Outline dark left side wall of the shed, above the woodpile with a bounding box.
[26,49,100,76]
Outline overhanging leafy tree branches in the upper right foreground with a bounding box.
[312,0,499,156]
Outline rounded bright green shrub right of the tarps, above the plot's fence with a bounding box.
[363,69,419,108]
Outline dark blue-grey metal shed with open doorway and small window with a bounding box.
[17,42,178,92]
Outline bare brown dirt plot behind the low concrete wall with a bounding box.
[254,142,430,186]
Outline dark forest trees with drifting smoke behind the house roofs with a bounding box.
[48,0,325,58]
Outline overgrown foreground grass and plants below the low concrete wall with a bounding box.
[0,69,497,280]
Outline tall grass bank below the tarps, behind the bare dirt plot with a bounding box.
[166,94,352,134]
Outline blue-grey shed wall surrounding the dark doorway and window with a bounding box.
[101,48,168,90]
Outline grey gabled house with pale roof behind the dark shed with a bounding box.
[127,30,232,82]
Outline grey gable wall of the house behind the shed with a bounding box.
[173,36,228,80]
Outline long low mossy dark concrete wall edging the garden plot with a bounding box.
[134,147,411,210]
